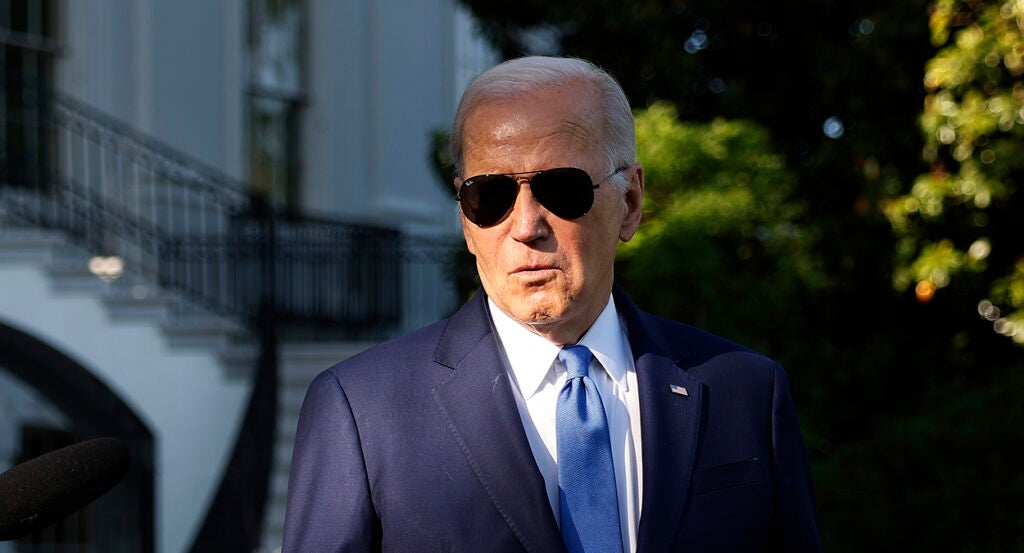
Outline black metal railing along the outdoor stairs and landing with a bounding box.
[0,91,455,337]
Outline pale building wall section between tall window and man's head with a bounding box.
[303,0,489,235]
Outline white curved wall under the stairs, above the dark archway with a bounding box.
[0,263,251,553]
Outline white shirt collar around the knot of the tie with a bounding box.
[487,296,629,398]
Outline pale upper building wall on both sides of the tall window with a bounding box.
[55,0,495,235]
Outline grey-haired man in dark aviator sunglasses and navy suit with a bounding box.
[285,57,821,553]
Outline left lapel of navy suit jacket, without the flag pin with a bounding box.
[432,291,563,551]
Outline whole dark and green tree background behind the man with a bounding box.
[444,0,1024,552]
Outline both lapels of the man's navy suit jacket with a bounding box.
[432,288,703,553]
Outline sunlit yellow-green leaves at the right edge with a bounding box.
[886,0,1024,344]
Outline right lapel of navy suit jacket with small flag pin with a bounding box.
[615,288,703,553]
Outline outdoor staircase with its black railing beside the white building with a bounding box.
[0,92,456,552]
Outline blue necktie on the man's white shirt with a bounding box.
[555,346,623,553]
